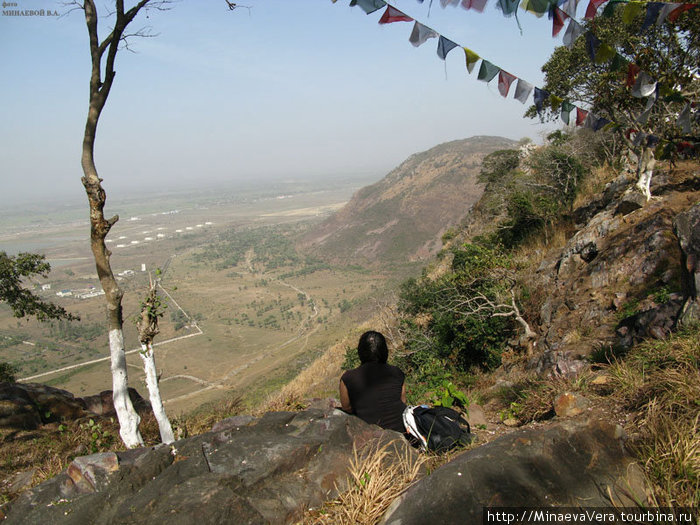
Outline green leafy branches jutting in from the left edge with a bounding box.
[0,252,78,321]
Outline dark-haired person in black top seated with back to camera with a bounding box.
[340,331,406,433]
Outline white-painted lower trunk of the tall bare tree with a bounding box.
[109,329,143,448]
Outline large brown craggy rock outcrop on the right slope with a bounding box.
[530,174,700,356]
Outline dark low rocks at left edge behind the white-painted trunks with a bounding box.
[0,382,151,430]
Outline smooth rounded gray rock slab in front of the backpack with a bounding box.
[382,421,646,525]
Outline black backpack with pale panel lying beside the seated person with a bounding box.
[403,405,474,452]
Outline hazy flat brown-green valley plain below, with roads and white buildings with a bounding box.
[0,176,408,413]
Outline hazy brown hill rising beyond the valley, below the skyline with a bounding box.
[300,136,516,263]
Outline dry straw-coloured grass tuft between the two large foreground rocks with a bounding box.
[302,443,428,525]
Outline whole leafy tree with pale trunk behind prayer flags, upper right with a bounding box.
[526,8,700,200]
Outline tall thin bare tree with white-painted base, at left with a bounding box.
[71,0,170,448]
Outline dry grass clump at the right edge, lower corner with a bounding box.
[610,326,700,507]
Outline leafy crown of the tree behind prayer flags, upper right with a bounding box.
[526,9,700,154]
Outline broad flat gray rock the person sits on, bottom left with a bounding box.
[6,409,416,525]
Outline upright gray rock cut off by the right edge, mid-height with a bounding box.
[673,202,700,323]
